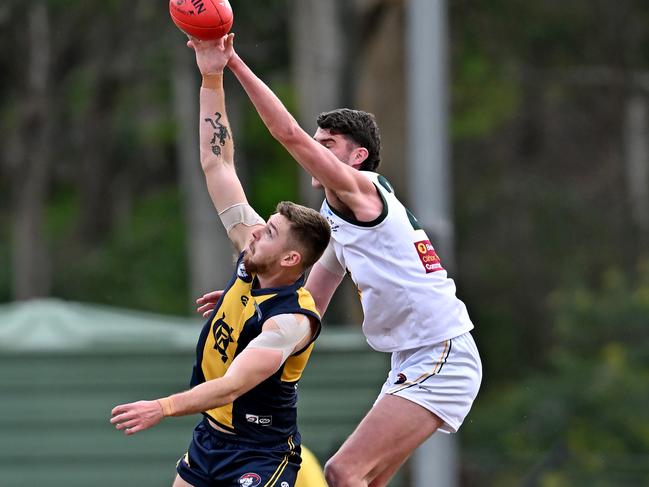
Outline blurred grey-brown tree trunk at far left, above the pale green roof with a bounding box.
[6,2,54,299]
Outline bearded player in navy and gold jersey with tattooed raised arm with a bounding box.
[111,37,330,487]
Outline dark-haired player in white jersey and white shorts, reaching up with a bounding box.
[198,35,482,487]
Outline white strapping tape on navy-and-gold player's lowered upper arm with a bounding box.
[248,314,311,363]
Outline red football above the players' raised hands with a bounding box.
[169,0,234,41]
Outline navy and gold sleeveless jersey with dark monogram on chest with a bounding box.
[191,253,320,441]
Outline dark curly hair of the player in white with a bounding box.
[317,108,381,171]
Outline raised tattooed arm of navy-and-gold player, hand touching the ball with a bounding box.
[187,35,264,251]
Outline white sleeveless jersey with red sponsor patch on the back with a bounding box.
[320,171,473,352]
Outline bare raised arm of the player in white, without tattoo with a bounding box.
[228,49,376,214]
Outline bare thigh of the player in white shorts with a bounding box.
[325,395,442,487]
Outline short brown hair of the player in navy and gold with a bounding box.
[276,201,331,269]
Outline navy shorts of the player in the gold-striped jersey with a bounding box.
[176,419,302,487]
